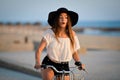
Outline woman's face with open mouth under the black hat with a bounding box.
[59,13,68,28]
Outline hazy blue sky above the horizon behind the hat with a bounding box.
[0,0,120,22]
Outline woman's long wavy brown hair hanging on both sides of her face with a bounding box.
[52,14,75,49]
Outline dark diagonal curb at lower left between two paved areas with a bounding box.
[0,60,41,78]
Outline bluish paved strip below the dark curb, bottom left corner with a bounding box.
[0,68,42,80]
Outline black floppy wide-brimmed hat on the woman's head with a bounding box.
[48,8,78,26]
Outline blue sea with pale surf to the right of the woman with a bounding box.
[43,20,120,37]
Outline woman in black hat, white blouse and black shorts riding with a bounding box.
[35,8,84,80]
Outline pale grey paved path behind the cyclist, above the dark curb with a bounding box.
[0,50,120,80]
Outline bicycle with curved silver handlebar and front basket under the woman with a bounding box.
[41,65,88,80]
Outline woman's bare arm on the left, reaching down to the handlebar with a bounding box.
[34,38,47,69]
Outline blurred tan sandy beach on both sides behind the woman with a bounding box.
[0,25,120,53]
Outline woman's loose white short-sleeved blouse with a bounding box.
[42,29,80,62]
